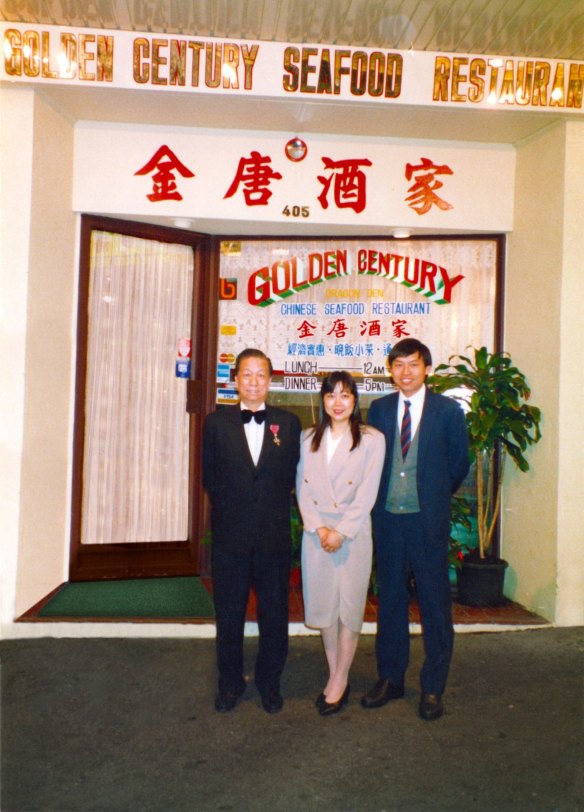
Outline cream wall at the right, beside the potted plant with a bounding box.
[503,122,584,625]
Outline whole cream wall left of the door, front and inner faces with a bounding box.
[0,88,76,636]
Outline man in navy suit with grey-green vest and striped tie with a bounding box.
[361,338,469,720]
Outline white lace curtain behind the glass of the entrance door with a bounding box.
[82,231,194,544]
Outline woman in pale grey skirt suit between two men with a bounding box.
[296,371,385,716]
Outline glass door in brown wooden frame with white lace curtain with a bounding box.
[70,221,212,580]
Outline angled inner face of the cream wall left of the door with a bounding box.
[16,89,77,615]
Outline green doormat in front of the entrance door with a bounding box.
[38,577,215,620]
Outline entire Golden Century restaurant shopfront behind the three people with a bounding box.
[0,0,584,638]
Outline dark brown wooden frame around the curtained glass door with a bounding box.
[69,215,219,581]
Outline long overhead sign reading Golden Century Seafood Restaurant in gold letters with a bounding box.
[0,22,584,114]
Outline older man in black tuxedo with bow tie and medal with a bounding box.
[203,349,300,713]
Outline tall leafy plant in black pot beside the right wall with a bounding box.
[430,347,541,606]
